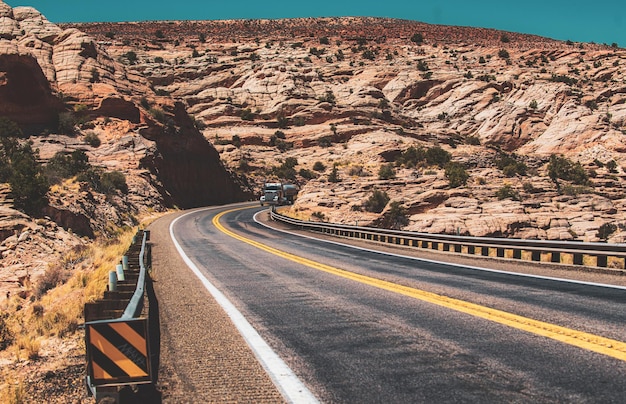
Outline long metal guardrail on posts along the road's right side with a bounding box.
[270,210,626,274]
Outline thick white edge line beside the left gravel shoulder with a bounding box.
[170,208,319,403]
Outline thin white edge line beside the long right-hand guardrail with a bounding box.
[254,210,626,290]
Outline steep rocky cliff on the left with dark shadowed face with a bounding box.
[0,1,249,295]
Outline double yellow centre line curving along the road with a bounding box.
[213,208,626,361]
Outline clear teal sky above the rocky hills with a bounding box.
[5,0,626,47]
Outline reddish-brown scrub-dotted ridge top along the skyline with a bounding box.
[61,17,606,48]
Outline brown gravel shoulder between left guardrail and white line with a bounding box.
[149,212,284,403]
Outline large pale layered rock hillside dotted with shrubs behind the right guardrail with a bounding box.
[67,18,626,241]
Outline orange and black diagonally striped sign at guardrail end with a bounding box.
[85,318,152,386]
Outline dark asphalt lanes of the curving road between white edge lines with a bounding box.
[168,208,626,403]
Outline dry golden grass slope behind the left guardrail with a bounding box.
[0,213,163,403]
